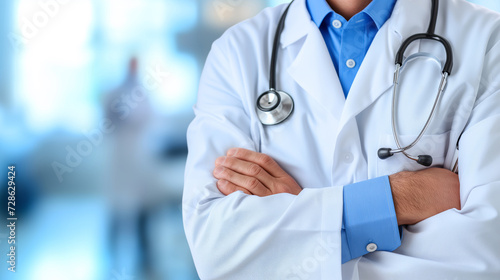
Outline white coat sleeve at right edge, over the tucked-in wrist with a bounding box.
[376,44,500,280]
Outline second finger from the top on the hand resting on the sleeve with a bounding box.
[215,157,276,189]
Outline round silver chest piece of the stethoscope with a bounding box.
[257,89,294,125]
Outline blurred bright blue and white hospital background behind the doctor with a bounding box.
[0,0,500,280]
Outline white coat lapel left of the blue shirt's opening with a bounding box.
[281,0,345,120]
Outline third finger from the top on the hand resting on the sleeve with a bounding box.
[213,166,272,196]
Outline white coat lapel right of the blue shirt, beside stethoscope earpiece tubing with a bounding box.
[340,0,431,127]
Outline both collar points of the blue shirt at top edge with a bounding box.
[306,0,396,29]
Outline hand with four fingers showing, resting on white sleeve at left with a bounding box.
[213,148,302,196]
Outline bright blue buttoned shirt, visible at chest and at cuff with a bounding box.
[306,0,401,263]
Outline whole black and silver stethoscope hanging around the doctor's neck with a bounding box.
[257,0,453,166]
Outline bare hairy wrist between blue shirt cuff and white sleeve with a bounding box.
[389,168,460,225]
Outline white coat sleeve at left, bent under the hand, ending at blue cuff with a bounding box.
[183,40,343,279]
